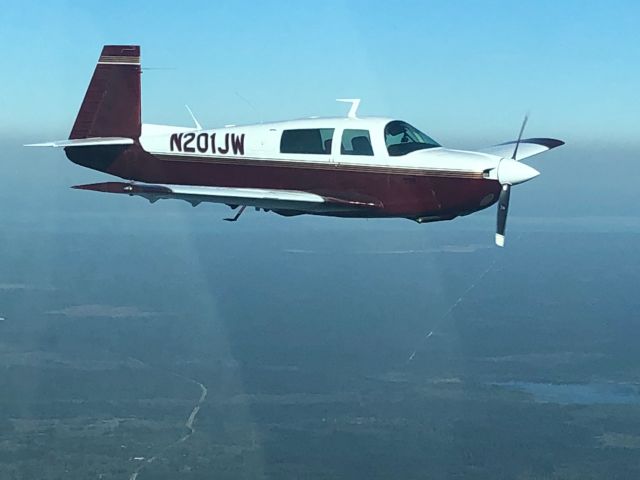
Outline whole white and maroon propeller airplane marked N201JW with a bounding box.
[27,45,564,247]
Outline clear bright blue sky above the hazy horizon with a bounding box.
[0,0,640,146]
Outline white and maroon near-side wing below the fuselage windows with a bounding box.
[72,182,383,213]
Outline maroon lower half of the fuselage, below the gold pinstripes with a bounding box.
[66,144,500,218]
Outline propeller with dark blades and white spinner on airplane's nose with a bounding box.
[496,115,539,247]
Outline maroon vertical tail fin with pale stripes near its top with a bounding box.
[69,45,142,140]
